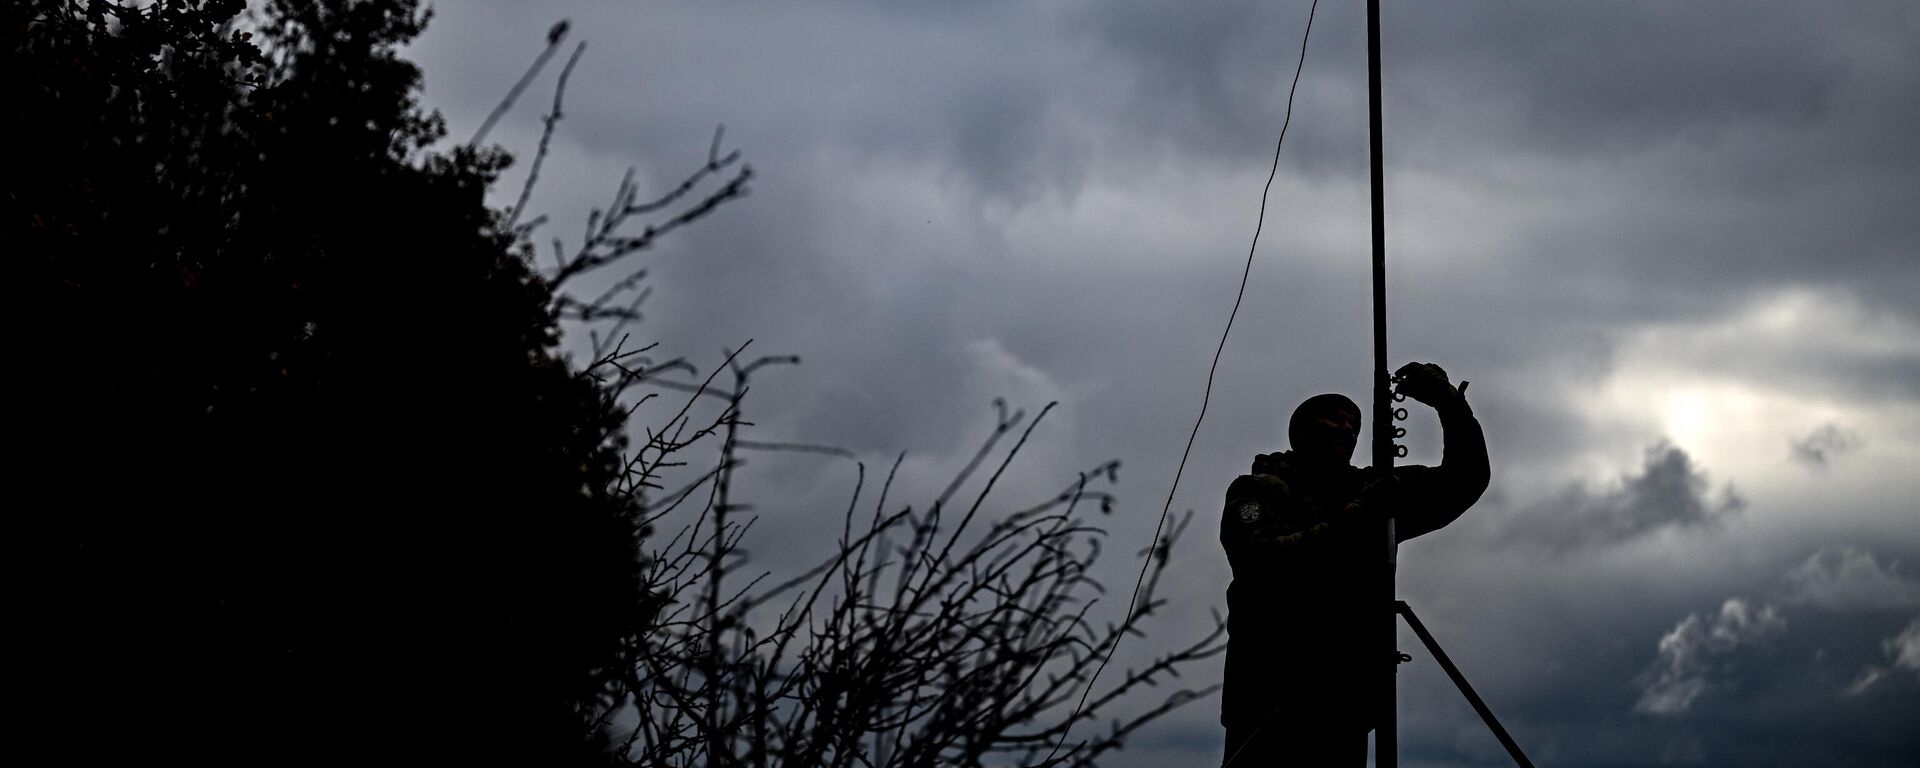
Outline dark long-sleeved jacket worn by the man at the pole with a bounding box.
[1219,399,1488,732]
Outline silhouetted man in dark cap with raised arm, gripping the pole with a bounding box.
[1219,363,1488,768]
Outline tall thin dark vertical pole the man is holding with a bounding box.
[1365,0,1400,768]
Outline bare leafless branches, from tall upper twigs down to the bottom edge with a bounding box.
[505,27,1225,766]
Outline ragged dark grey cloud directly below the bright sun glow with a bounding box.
[1507,442,1747,551]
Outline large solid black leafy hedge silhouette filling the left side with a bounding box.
[0,0,679,764]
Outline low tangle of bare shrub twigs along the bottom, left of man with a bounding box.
[591,362,1225,766]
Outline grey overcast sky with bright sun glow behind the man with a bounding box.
[409,0,1920,766]
